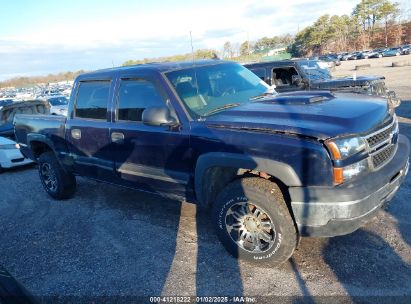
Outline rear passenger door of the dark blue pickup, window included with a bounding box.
[66,80,114,180]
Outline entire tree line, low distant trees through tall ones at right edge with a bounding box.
[227,0,411,60]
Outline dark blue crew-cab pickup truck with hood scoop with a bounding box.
[14,60,410,264]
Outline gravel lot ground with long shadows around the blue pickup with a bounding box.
[0,57,411,303]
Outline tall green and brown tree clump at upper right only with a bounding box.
[290,0,410,56]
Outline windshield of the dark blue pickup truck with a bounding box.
[166,63,275,118]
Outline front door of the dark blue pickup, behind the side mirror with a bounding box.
[110,72,192,197]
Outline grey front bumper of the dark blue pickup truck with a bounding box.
[290,135,410,237]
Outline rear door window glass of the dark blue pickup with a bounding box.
[75,81,110,120]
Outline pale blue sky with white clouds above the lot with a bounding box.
[0,0,405,81]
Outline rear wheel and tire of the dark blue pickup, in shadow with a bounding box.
[38,152,76,200]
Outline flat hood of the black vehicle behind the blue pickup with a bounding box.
[310,76,385,90]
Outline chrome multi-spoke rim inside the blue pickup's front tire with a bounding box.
[225,202,276,253]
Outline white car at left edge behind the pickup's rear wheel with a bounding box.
[0,137,32,172]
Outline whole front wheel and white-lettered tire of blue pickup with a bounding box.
[212,177,299,265]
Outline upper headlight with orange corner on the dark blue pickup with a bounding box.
[325,137,366,160]
